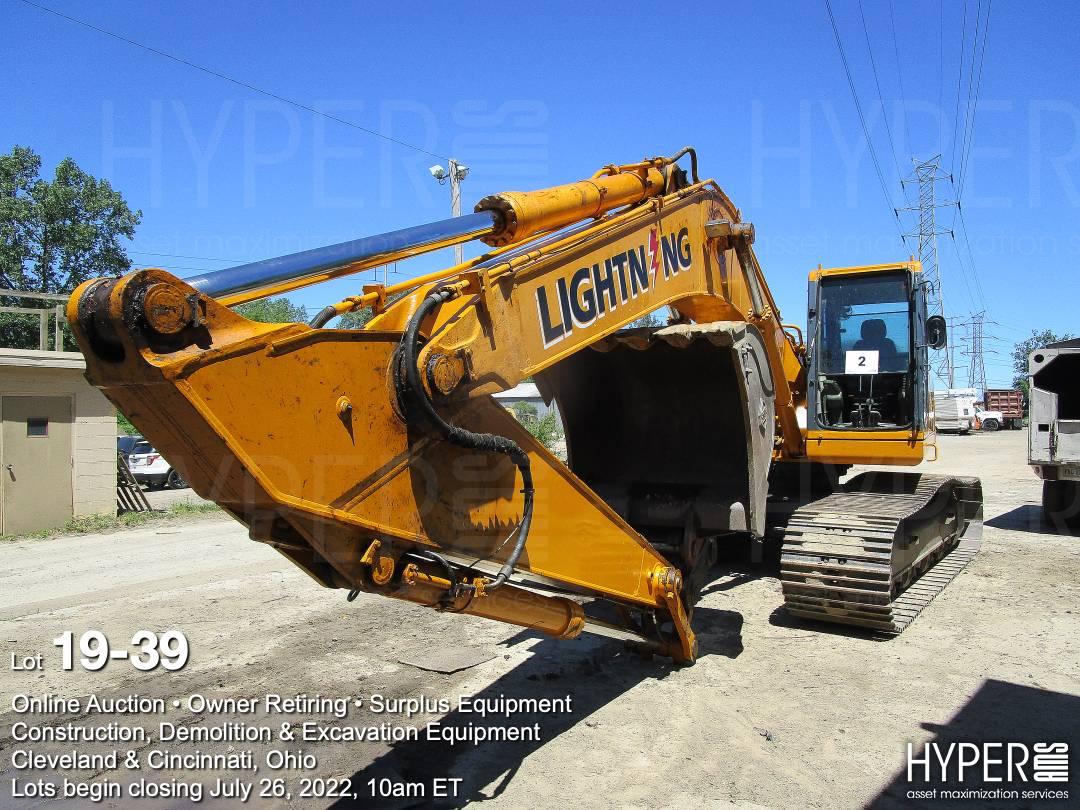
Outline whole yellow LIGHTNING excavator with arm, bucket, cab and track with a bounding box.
[67,148,982,663]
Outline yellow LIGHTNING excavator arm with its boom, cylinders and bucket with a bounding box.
[68,150,806,662]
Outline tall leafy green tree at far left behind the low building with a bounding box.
[0,146,143,293]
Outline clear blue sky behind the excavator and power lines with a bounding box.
[0,0,1080,384]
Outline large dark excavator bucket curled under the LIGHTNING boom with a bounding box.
[537,322,774,607]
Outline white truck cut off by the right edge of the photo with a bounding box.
[1027,338,1080,527]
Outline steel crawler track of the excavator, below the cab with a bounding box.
[780,473,983,635]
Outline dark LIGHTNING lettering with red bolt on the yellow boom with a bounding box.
[537,228,692,349]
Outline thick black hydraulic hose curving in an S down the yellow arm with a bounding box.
[396,288,535,591]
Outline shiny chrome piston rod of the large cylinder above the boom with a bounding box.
[185,211,499,306]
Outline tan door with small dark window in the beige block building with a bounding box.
[0,396,72,535]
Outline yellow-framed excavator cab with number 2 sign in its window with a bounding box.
[807,261,929,463]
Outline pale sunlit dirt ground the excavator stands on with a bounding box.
[0,432,1080,808]
